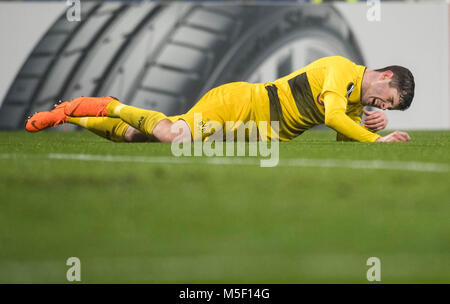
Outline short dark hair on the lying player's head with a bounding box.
[375,65,415,111]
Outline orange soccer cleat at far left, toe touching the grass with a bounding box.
[25,101,69,132]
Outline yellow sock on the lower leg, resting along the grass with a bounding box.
[67,116,129,142]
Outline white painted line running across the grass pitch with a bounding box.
[0,153,450,172]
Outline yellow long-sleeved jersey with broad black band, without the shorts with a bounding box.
[255,56,379,142]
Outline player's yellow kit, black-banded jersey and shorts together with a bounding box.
[176,56,379,142]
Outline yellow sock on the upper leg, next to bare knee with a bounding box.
[106,101,167,135]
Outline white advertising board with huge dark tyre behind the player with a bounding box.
[0,0,450,130]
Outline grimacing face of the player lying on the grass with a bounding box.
[362,71,400,110]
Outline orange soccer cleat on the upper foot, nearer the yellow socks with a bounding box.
[64,96,120,117]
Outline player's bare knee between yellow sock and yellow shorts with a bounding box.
[153,119,191,142]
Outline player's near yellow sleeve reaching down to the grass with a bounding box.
[324,91,380,142]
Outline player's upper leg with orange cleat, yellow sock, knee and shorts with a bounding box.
[65,82,252,142]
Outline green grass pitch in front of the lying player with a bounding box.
[0,131,450,283]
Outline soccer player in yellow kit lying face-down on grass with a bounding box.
[26,56,415,142]
